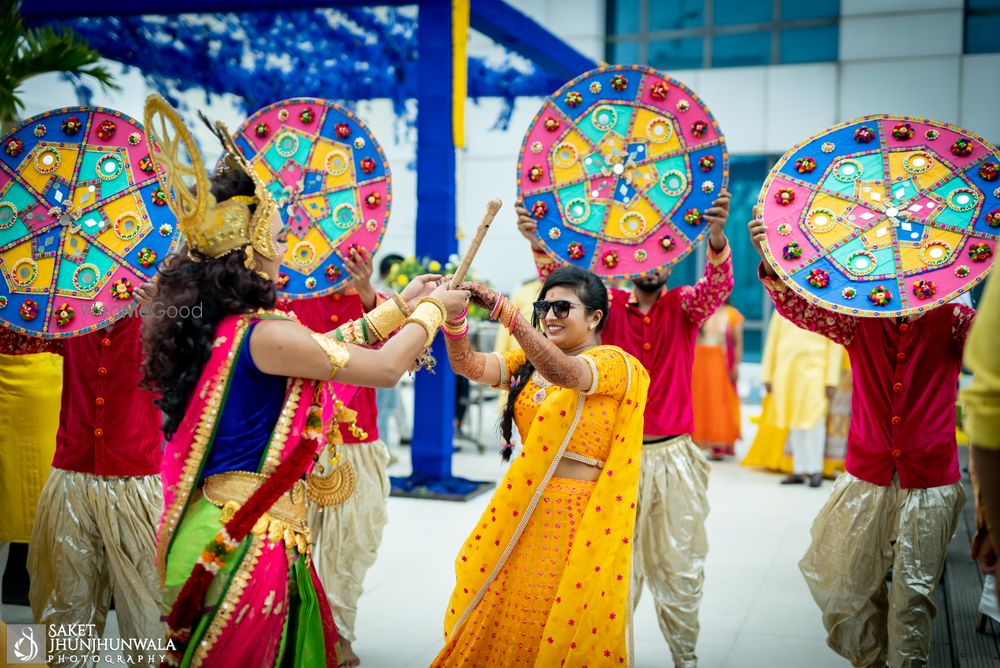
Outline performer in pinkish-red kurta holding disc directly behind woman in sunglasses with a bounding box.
[518,192,733,668]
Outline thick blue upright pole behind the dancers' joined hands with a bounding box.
[411,0,458,484]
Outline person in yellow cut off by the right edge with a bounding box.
[962,278,1000,599]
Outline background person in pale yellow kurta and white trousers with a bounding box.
[743,314,844,487]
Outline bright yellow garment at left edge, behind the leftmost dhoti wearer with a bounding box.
[0,353,62,609]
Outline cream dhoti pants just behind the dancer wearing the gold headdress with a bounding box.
[309,441,389,643]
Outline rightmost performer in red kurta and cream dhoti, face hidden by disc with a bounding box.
[750,220,975,667]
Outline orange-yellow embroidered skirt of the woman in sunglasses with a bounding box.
[433,478,595,666]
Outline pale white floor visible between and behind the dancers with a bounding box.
[4,408,848,668]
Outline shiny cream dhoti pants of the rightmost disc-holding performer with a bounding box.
[799,473,965,668]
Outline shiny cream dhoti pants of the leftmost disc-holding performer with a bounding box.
[28,468,166,666]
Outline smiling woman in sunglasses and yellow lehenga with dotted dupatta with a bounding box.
[433,266,649,666]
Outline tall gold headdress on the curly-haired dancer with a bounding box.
[143,95,279,267]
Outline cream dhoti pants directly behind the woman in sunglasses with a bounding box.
[632,435,711,668]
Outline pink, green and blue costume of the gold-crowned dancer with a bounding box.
[157,313,354,667]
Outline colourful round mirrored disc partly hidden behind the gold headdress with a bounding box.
[229,98,392,298]
